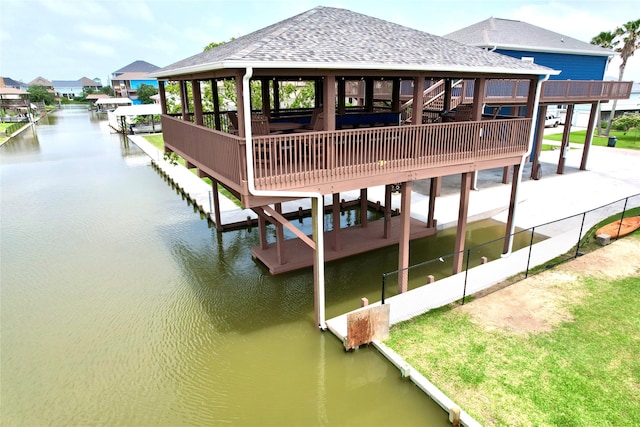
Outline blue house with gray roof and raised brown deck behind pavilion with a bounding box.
[444,17,632,179]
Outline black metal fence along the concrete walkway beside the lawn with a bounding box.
[381,193,640,308]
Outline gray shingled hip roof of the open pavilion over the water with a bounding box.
[150,7,555,78]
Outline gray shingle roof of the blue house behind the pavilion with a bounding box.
[444,17,613,56]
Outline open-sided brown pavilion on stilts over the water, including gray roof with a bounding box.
[152,7,632,329]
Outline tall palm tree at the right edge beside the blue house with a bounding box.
[591,19,640,136]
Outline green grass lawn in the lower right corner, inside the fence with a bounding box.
[385,231,640,426]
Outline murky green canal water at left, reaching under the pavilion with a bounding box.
[0,107,456,426]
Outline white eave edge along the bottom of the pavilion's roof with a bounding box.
[149,61,560,79]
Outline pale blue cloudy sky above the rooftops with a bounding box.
[0,0,640,84]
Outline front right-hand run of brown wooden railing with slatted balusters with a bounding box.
[253,119,531,190]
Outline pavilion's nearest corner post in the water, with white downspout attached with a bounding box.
[311,197,327,329]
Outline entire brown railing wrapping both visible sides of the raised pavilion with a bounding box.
[162,115,531,192]
